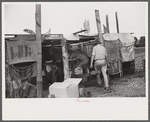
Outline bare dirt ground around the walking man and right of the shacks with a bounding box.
[43,47,145,98]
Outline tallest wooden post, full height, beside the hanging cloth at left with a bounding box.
[36,4,43,98]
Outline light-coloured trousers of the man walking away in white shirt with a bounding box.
[94,60,109,87]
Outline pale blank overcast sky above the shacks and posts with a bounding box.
[3,2,148,38]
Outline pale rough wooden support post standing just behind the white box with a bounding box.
[61,38,70,80]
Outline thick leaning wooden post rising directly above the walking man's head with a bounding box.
[95,10,104,45]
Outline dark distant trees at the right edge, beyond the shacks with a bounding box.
[134,36,145,47]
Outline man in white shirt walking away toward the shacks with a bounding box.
[90,41,110,92]
